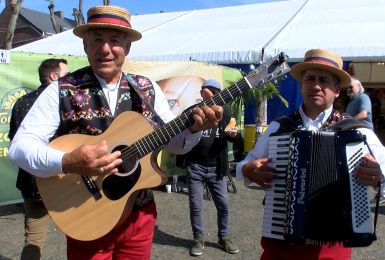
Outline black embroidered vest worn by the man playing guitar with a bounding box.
[55,67,155,206]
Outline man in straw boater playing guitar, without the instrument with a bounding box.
[9,6,223,260]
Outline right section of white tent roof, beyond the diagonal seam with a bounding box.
[265,0,385,61]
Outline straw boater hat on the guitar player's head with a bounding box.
[73,5,142,41]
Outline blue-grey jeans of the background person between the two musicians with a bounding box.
[186,163,229,237]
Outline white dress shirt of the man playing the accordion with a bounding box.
[236,106,385,185]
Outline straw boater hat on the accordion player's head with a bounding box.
[291,49,351,88]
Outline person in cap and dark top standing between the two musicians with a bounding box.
[183,79,239,256]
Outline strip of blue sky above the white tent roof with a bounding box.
[0,0,278,18]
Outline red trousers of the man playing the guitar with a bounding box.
[67,202,157,260]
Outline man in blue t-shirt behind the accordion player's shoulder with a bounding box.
[346,77,373,129]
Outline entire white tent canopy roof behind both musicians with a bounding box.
[13,0,385,64]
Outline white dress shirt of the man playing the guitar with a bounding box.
[8,74,201,177]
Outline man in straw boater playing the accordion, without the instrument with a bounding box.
[236,49,385,260]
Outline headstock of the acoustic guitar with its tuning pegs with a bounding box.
[245,52,290,88]
